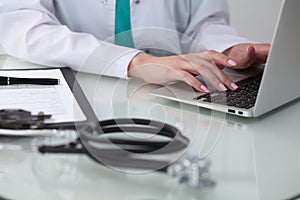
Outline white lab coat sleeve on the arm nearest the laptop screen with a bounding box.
[185,0,252,52]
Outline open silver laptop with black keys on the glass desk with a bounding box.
[151,0,300,117]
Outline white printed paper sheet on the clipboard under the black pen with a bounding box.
[0,69,86,123]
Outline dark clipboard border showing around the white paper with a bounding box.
[0,67,98,133]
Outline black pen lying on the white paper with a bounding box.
[0,76,59,85]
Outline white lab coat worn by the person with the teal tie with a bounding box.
[0,0,249,77]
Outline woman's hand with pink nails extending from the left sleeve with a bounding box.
[128,50,237,93]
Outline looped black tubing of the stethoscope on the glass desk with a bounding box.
[39,118,189,172]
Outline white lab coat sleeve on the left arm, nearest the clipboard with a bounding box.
[0,0,139,78]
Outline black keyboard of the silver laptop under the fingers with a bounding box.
[194,74,262,109]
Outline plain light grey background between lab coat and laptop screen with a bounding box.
[0,0,282,54]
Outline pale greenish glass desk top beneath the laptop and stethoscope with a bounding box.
[0,56,300,200]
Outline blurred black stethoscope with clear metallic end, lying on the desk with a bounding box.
[0,110,214,188]
